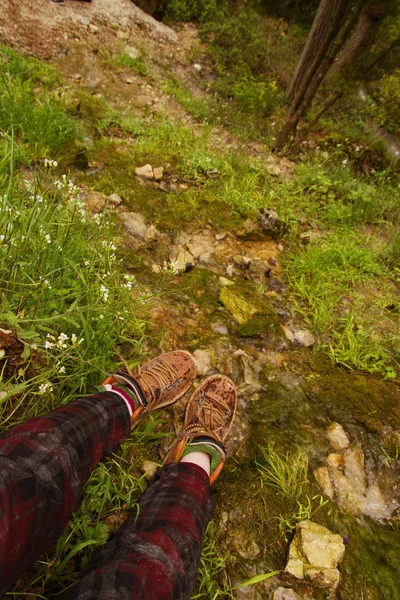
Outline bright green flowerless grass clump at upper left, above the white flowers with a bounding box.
[0,49,77,158]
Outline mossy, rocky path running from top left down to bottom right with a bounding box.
[0,0,400,600]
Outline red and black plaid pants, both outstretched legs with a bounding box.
[0,392,213,600]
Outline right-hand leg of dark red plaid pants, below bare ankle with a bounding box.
[62,463,213,600]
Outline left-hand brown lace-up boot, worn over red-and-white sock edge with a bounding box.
[102,350,197,421]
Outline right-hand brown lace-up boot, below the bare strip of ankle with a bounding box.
[164,375,237,483]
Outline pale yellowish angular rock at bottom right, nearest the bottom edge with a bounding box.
[285,521,345,589]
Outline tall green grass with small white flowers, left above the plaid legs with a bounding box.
[0,137,146,425]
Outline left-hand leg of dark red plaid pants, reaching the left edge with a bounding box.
[0,392,130,597]
